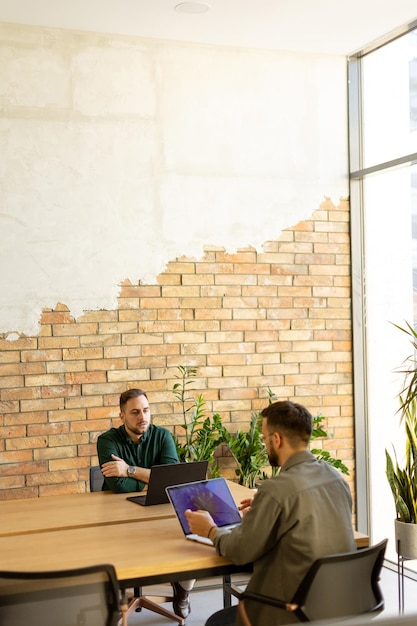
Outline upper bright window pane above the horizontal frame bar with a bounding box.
[362,30,417,167]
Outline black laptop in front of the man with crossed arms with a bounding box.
[127,461,208,506]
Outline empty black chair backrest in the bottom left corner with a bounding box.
[0,565,119,626]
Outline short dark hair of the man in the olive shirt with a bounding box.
[261,400,313,445]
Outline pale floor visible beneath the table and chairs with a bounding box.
[125,567,417,626]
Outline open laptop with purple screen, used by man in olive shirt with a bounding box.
[166,478,242,546]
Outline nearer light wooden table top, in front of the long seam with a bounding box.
[0,505,243,584]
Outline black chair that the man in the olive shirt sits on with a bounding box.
[231,539,388,626]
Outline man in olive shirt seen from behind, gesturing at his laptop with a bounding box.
[186,402,356,626]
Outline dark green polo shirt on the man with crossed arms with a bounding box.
[97,424,179,493]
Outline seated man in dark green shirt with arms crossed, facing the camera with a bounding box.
[97,389,194,619]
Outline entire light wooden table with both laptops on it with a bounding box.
[0,483,369,612]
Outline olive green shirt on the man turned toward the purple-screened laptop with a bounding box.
[214,450,356,626]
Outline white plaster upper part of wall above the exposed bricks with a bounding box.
[0,24,348,338]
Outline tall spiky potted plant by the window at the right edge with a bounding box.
[385,323,417,559]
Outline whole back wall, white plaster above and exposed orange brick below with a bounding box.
[0,24,354,499]
